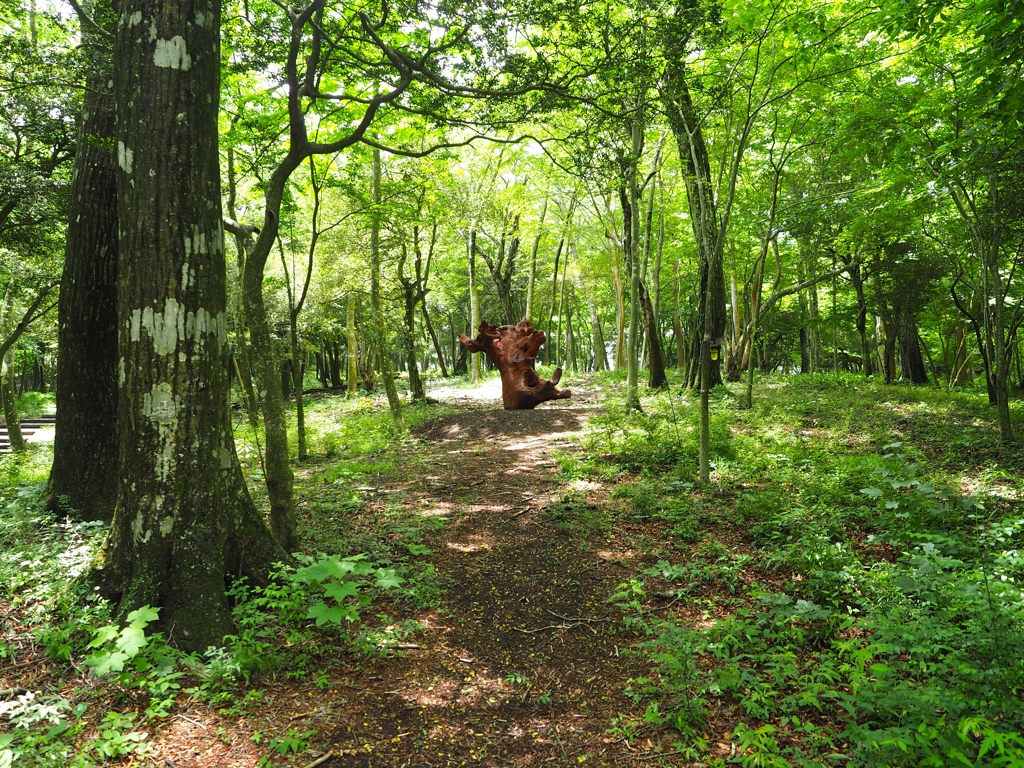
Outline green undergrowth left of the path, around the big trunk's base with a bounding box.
[0,397,443,768]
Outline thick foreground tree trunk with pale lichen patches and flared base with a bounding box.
[93,0,286,650]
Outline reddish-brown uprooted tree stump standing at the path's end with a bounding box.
[459,317,571,411]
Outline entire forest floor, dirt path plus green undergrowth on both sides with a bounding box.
[0,377,1024,768]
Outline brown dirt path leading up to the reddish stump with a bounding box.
[299,384,657,768]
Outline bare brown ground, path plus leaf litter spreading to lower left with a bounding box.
[136,381,728,768]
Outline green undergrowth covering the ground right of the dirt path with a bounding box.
[589,377,1024,768]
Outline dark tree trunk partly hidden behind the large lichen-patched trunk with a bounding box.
[48,0,118,520]
